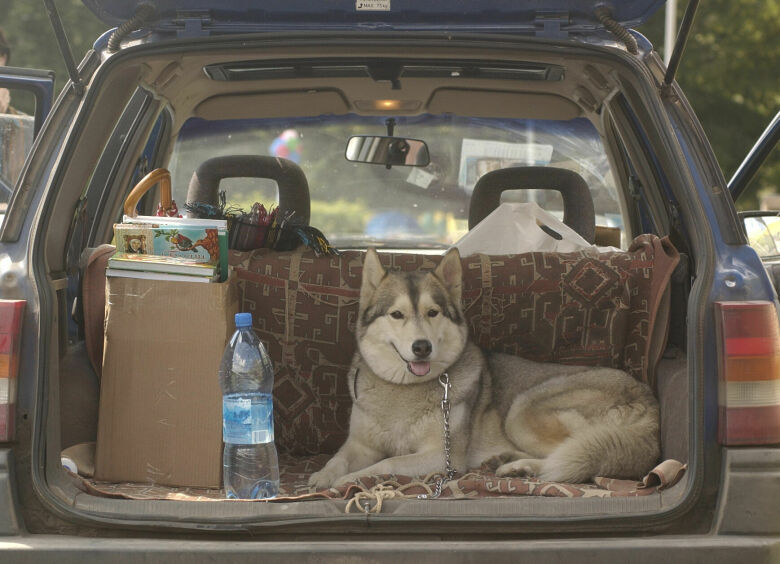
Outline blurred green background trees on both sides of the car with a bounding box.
[0,0,780,208]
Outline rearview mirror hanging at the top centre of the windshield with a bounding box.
[345,135,431,167]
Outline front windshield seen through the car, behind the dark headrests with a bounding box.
[170,115,622,248]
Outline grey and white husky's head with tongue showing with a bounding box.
[357,249,468,384]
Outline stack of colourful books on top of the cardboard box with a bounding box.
[106,216,228,282]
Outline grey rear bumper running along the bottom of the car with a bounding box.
[0,448,780,544]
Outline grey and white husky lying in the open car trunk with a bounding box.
[309,249,660,488]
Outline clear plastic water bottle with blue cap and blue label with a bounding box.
[219,313,279,499]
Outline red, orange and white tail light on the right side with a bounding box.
[715,301,780,445]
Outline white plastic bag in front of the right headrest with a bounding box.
[454,202,595,257]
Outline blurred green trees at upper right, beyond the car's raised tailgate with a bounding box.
[639,0,780,209]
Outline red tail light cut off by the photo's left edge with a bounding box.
[0,300,26,442]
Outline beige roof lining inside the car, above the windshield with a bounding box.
[128,44,611,135]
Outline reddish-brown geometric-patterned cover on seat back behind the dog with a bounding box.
[231,235,679,455]
